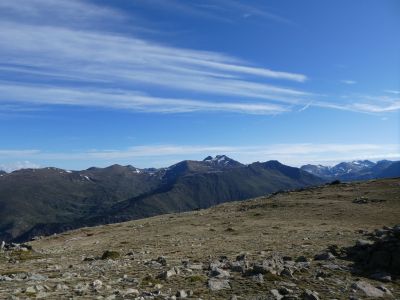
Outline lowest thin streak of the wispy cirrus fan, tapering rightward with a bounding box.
[0,84,288,115]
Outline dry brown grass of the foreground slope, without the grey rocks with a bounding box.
[0,179,400,299]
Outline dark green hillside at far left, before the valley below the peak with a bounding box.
[0,166,157,240]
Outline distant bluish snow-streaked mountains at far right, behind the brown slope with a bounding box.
[301,160,400,181]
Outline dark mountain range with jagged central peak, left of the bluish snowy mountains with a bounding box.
[0,155,323,240]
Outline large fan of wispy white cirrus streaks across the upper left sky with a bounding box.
[0,0,308,114]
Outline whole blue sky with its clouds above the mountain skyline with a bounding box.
[0,0,400,171]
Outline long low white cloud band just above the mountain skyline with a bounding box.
[2,143,400,169]
